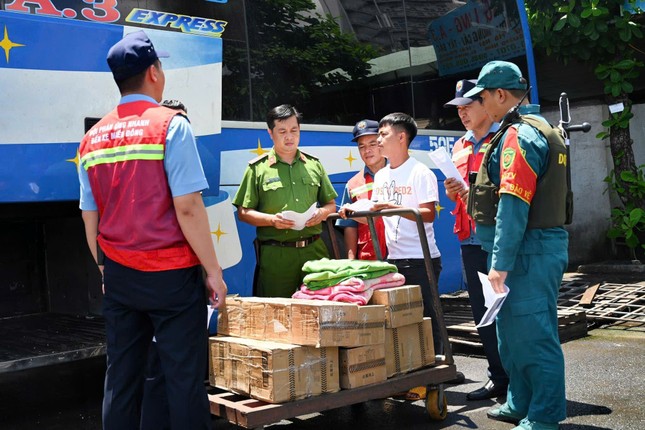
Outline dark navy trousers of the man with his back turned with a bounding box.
[103,259,211,430]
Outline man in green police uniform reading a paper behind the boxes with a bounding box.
[233,105,337,297]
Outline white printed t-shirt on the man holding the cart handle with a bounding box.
[372,157,441,260]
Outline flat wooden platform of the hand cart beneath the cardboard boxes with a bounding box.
[208,364,457,428]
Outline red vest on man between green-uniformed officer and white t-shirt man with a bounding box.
[347,169,387,260]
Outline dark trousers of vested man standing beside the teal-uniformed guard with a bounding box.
[461,245,508,385]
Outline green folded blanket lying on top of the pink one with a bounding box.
[302,258,397,290]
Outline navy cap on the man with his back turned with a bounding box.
[107,30,170,81]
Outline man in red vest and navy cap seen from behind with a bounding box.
[79,31,227,430]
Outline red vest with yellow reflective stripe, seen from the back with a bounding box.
[79,101,200,272]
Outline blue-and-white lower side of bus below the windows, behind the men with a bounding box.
[215,126,464,296]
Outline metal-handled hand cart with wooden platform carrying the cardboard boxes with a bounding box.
[208,208,457,428]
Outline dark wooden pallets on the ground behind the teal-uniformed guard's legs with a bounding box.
[444,304,587,348]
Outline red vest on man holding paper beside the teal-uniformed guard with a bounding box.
[451,133,495,240]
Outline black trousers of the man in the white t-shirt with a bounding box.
[387,257,443,354]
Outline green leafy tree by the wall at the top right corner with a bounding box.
[525,0,645,253]
